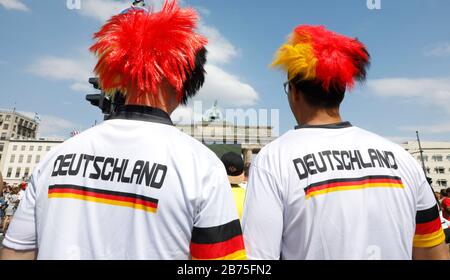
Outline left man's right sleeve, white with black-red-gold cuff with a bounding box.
[190,166,246,260]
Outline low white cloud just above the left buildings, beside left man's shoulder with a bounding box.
[20,112,80,138]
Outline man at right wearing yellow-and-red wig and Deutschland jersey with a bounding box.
[243,26,449,259]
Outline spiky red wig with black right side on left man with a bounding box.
[90,0,207,103]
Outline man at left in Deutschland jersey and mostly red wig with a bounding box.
[2,0,245,260]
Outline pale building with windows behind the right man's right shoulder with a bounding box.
[402,141,450,191]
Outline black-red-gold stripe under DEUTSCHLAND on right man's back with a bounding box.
[305,176,404,199]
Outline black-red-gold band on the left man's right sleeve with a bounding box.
[190,220,246,260]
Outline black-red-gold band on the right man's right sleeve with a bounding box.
[413,204,445,248]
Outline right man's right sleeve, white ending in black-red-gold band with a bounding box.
[413,172,445,248]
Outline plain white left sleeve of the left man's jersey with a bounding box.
[3,173,37,251]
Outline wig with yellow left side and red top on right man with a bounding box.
[272,25,370,90]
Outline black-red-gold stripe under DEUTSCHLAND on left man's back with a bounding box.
[48,185,158,213]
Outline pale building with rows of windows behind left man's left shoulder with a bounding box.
[0,138,64,184]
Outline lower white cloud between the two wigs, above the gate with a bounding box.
[198,64,258,106]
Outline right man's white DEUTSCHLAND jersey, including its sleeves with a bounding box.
[243,122,444,259]
